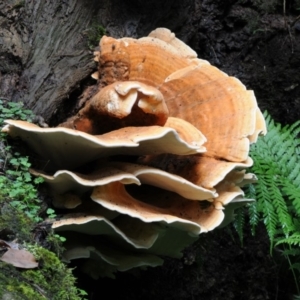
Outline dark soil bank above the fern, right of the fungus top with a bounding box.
[190,0,300,124]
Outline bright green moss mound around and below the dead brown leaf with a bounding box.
[0,245,86,300]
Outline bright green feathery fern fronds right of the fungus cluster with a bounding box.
[235,112,300,299]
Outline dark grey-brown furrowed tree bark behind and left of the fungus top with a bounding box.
[0,0,202,122]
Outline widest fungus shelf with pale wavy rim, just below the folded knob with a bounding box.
[2,120,205,169]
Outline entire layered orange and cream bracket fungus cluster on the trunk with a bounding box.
[3,28,266,278]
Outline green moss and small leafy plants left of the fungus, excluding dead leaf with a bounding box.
[0,99,87,300]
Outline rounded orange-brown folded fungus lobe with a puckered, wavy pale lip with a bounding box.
[60,81,169,135]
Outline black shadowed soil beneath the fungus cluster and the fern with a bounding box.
[75,226,293,300]
